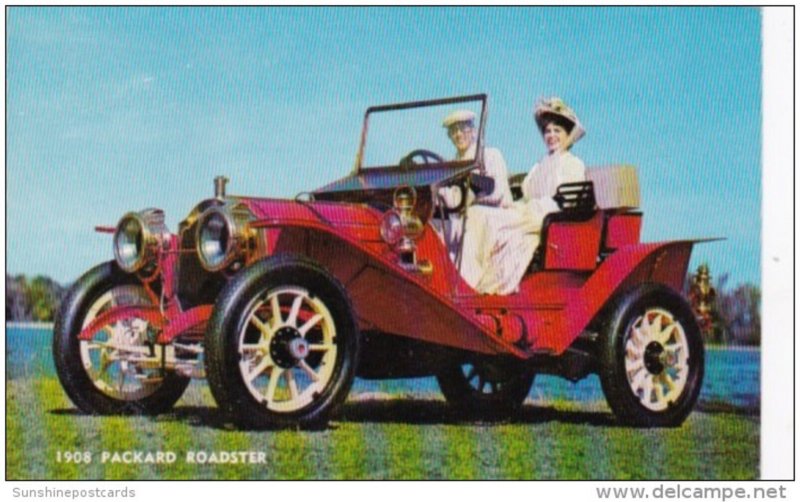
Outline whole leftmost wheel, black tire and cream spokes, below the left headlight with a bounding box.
[53,262,189,415]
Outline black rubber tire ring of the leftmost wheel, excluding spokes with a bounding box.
[53,261,189,415]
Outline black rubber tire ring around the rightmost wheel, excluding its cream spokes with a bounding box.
[599,284,705,427]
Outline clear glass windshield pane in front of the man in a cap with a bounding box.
[361,97,483,169]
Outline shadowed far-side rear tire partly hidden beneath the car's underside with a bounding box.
[436,359,534,420]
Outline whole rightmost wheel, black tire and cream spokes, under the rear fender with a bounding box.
[600,284,704,427]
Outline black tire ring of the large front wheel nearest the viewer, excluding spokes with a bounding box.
[205,254,359,429]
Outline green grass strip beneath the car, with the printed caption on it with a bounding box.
[6,377,760,480]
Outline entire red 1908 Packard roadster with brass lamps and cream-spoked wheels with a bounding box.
[53,94,704,427]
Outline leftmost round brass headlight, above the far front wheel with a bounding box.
[114,209,167,273]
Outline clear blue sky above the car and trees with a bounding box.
[6,7,761,283]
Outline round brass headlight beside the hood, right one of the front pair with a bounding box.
[197,207,250,272]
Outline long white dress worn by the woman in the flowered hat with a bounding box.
[462,151,586,295]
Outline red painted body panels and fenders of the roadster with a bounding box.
[80,185,705,359]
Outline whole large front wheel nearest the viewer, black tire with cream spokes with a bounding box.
[206,256,358,427]
